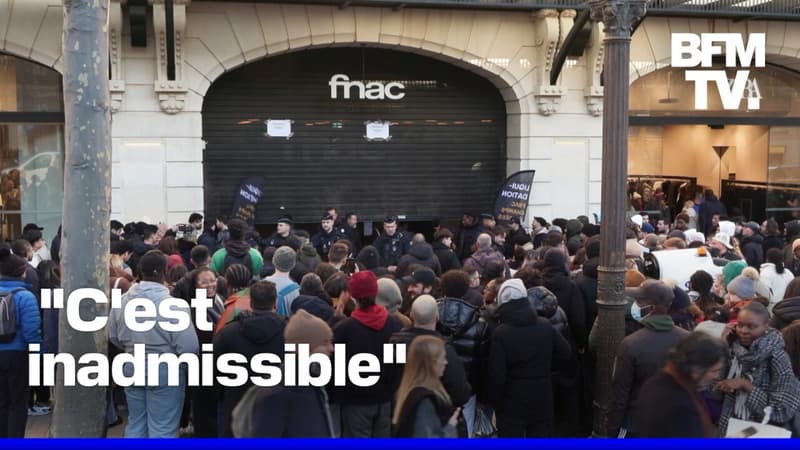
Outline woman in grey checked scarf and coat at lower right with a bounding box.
[714,302,800,436]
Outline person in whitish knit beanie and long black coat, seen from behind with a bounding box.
[489,279,571,437]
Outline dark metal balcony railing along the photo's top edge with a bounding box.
[223,0,800,21]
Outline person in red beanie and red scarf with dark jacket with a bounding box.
[331,271,402,438]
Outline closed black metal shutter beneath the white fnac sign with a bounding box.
[203,48,506,224]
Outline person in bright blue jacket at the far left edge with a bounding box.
[0,244,41,438]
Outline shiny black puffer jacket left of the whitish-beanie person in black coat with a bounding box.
[436,297,490,401]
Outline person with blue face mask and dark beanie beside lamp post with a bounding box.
[606,280,688,437]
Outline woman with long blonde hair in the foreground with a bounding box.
[392,336,461,438]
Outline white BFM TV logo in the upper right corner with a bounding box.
[672,33,766,110]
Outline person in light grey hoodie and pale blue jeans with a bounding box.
[106,250,200,438]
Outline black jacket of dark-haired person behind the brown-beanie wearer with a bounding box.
[214,311,286,437]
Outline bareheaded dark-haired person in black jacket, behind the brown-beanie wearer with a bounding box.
[212,281,286,437]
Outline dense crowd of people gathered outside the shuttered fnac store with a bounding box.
[0,198,800,437]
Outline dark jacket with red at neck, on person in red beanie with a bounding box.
[331,305,402,405]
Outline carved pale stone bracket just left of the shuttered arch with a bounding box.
[149,0,191,114]
